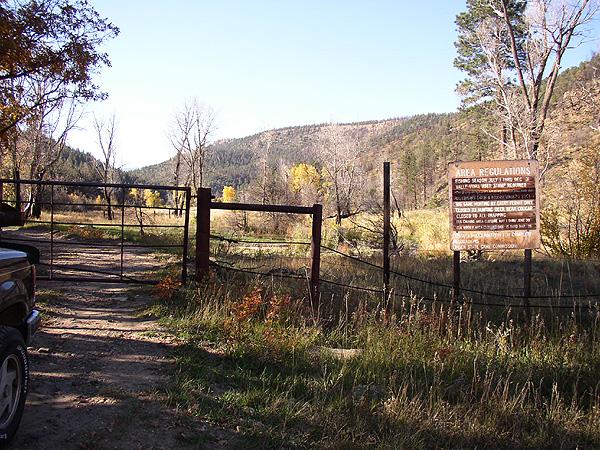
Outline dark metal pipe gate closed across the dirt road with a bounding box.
[0,179,192,284]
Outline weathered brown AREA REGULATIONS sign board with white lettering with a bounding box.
[448,160,540,250]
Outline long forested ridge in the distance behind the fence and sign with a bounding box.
[130,56,600,208]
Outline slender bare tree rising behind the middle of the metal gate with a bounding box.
[94,114,118,220]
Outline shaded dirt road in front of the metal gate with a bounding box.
[11,283,231,450]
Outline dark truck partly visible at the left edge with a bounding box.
[0,206,40,447]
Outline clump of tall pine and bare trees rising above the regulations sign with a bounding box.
[455,0,598,158]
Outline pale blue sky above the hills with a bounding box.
[69,0,600,169]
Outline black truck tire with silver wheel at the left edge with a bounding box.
[0,326,29,447]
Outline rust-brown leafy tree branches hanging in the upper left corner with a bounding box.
[0,0,119,137]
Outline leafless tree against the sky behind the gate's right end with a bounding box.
[170,99,215,190]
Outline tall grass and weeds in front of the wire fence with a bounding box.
[150,279,600,448]
